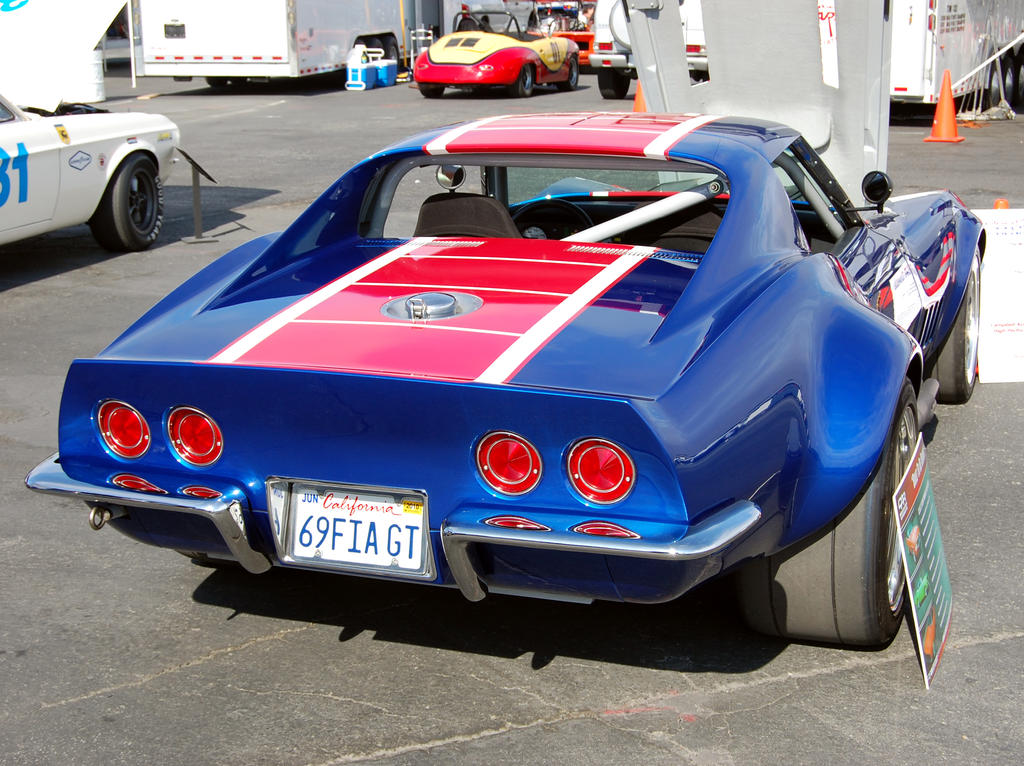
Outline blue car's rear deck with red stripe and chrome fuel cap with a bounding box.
[102,238,697,397]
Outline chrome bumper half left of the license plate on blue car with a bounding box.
[25,453,270,575]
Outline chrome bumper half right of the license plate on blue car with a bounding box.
[441,500,761,601]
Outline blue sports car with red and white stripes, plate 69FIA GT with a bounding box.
[27,114,985,645]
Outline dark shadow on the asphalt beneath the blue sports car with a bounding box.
[193,565,787,674]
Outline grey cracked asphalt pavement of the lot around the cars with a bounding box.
[0,70,1024,766]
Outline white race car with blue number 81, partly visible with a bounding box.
[0,91,178,252]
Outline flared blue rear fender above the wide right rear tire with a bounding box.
[648,255,915,552]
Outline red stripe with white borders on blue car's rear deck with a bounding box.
[210,239,650,382]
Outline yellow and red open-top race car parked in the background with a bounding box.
[414,11,580,98]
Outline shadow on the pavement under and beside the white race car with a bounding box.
[0,185,279,292]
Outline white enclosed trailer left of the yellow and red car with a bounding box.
[131,0,460,84]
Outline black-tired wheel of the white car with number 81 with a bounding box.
[89,154,164,253]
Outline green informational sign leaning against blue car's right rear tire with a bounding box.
[893,435,953,688]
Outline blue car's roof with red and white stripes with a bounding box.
[403,112,799,162]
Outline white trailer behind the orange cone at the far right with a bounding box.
[890,0,1024,109]
